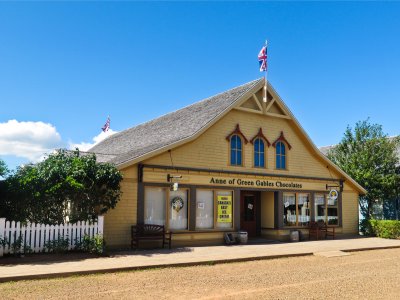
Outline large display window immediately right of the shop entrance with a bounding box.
[283,193,310,226]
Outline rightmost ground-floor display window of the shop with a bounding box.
[314,194,339,225]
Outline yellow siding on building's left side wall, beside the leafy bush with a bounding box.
[104,165,138,248]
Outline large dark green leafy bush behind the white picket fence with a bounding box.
[0,150,122,224]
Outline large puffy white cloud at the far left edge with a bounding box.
[0,120,64,162]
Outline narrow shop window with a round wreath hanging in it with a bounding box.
[169,189,188,230]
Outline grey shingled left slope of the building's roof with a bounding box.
[89,78,264,165]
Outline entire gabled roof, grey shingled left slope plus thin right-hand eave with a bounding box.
[89,78,367,194]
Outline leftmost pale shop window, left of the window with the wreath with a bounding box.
[144,187,167,225]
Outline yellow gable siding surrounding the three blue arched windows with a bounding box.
[144,110,337,178]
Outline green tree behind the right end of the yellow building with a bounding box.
[328,120,400,219]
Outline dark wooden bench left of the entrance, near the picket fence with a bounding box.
[131,224,172,249]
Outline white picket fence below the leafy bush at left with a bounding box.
[0,216,104,257]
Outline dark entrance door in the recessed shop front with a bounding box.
[240,191,257,237]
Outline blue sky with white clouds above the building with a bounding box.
[0,2,400,168]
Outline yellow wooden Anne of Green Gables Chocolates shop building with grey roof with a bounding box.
[90,79,366,247]
